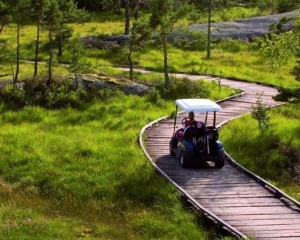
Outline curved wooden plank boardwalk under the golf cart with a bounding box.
[140,71,300,240]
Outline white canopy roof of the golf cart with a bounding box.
[175,98,222,112]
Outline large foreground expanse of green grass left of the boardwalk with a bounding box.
[0,95,220,239]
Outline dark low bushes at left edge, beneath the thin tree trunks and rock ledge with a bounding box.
[0,77,119,110]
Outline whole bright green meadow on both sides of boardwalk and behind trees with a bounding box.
[0,6,300,240]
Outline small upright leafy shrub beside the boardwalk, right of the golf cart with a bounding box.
[251,95,271,134]
